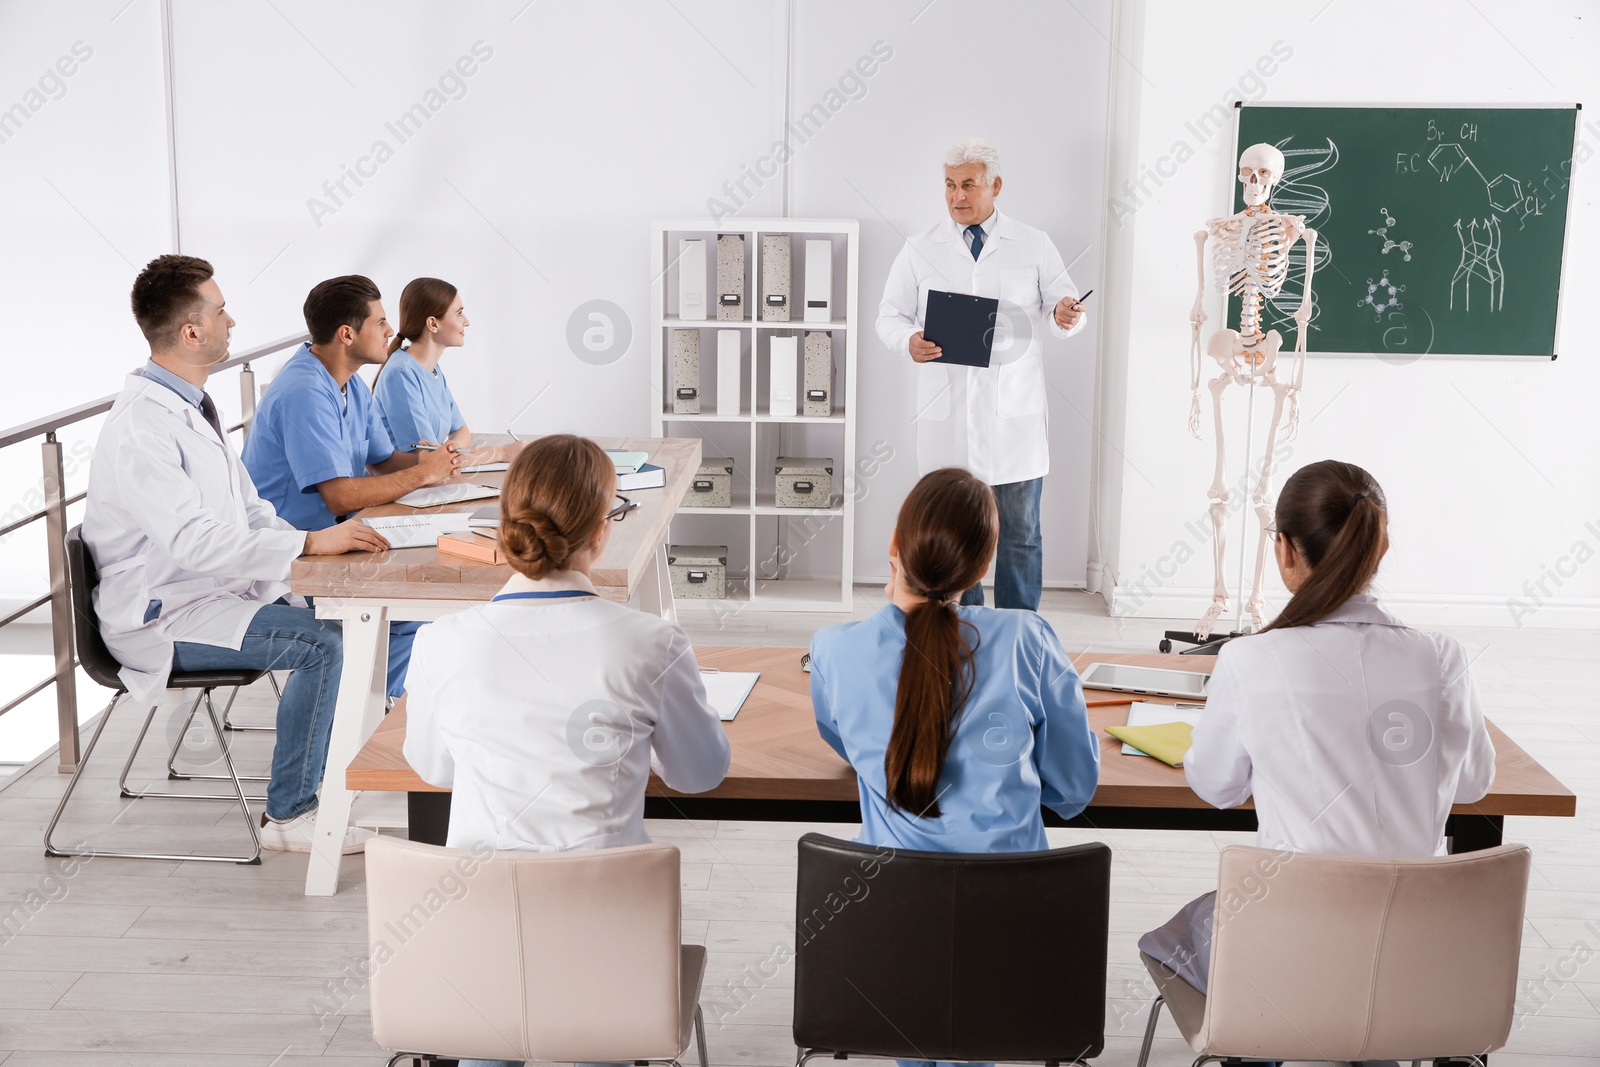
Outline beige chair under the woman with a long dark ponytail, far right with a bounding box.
[1139,845,1531,1067]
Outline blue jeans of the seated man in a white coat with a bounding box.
[173,600,339,821]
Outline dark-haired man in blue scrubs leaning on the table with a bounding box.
[243,274,461,697]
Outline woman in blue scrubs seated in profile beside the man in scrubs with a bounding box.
[373,278,522,464]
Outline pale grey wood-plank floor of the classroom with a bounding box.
[0,589,1600,1067]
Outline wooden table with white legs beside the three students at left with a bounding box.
[290,434,701,896]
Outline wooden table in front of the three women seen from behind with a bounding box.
[346,648,1578,851]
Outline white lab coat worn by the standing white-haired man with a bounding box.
[878,211,1086,485]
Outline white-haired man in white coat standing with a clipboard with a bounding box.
[878,138,1083,611]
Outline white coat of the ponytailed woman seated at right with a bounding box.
[1184,593,1494,856]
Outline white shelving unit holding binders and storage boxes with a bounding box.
[650,218,861,611]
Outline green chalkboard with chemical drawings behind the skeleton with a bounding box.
[1229,104,1578,360]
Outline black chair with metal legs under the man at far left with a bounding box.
[45,526,266,864]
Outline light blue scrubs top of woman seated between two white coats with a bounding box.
[811,605,1099,853]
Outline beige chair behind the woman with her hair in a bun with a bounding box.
[366,837,706,1067]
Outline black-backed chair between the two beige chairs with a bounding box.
[794,833,1110,1067]
